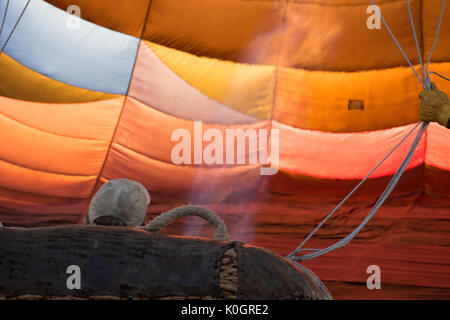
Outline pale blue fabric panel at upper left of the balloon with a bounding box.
[0,0,140,95]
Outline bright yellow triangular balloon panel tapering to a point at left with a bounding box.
[145,41,275,119]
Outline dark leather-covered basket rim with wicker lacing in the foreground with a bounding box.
[0,208,331,300]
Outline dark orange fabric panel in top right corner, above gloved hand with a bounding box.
[422,0,450,62]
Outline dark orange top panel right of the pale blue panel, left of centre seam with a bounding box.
[143,0,285,64]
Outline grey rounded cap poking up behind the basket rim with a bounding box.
[88,179,150,227]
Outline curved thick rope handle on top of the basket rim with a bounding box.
[142,206,230,241]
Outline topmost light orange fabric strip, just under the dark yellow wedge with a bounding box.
[0,97,125,141]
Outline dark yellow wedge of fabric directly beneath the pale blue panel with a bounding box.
[0,53,117,103]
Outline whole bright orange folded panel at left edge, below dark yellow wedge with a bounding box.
[0,97,124,198]
